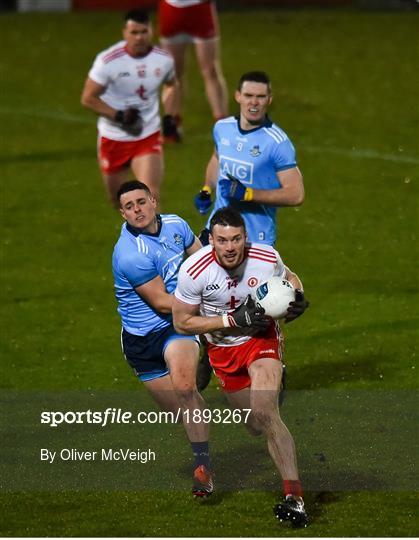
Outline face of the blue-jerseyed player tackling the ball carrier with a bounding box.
[120,189,157,232]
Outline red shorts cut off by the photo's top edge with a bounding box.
[158,0,219,39]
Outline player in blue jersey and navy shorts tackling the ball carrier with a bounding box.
[112,180,213,497]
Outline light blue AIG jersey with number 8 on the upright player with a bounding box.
[207,116,297,245]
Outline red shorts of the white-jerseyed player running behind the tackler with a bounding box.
[98,131,162,174]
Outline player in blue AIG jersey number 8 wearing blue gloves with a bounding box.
[194,71,304,390]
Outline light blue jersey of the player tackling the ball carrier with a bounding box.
[112,214,195,336]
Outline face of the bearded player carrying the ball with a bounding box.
[209,225,246,270]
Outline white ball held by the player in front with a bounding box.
[254,276,295,320]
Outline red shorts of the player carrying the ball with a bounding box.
[208,325,283,392]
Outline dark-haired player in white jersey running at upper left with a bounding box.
[81,10,178,208]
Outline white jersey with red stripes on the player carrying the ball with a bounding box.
[175,243,286,347]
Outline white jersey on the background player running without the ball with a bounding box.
[89,41,175,141]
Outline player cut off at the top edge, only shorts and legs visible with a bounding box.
[158,0,228,127]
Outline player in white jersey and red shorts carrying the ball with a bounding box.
[173,208,308,526]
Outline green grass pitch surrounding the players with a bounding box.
[0,6,419,536]
